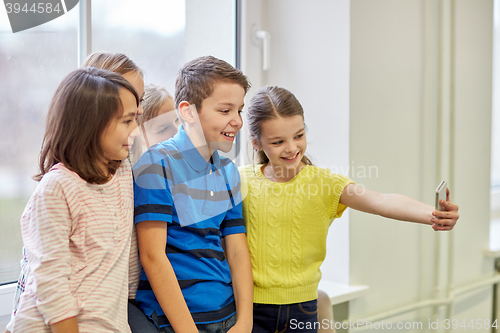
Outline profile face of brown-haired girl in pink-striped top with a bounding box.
[101,88,138,166]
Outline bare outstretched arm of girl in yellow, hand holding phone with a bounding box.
[340,184,459,231]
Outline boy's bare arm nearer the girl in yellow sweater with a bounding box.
[224,233,253,332]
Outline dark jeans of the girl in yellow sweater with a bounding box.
[252,300,319,333]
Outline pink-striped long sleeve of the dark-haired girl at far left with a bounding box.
[21,192,83,325]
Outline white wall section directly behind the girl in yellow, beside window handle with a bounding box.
[243,0,349,283]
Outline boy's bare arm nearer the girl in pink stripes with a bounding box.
[136,221,198,332]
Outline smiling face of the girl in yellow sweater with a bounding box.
[253,115,307,174]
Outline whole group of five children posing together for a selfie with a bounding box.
[3,53,458,333]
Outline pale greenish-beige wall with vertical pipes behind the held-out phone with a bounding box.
[350,0,493,331]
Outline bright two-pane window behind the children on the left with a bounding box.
[0,0,236,286]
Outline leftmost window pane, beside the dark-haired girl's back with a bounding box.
[0,6,78,283]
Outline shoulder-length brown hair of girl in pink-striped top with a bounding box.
[34,67,139,183]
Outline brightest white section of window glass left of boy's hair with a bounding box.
[92,0,186,95]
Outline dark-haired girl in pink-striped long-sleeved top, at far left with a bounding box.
[12,68,139,333]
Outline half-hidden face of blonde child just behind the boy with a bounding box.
[144,98,179,145]
